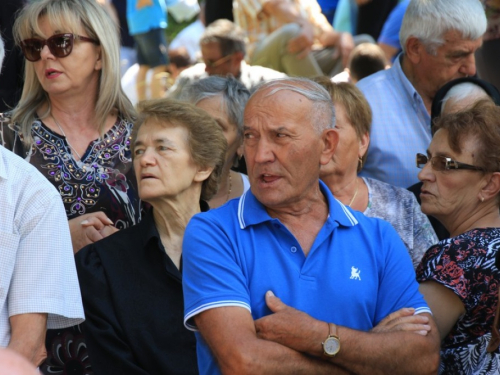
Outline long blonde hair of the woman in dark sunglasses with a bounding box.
[12,0,136,146]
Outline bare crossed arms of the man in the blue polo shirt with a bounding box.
[195,293,439,374]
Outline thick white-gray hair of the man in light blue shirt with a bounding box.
[399,0,486,55]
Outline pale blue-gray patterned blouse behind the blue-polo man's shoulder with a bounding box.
[363,177,439,268]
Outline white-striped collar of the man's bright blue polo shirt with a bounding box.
[237,180,358,229]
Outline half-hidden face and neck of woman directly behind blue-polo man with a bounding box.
[320,103,368,177]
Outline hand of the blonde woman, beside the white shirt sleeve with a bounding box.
[69,211,118,254]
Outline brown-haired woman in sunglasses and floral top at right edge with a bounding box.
[417,100,500,374]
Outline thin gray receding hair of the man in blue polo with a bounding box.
[250,77,335,134]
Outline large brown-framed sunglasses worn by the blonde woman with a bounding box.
[21,33,99,62]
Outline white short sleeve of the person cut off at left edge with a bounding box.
[8,189,84,329]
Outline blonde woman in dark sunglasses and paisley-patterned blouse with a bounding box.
[0,0,140,374]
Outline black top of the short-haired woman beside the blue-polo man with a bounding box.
[76,207,206,375]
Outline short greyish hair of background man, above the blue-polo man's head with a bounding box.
[200,19,246,57]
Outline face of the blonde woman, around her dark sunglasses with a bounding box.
[28,16,102,98]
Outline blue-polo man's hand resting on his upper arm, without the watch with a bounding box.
[370,308,431,336]
